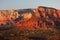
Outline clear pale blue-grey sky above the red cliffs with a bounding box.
[0,0,60,10]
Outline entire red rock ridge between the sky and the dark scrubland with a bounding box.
[0,6,60,30]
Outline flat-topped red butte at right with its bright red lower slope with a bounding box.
[17,6,60,30]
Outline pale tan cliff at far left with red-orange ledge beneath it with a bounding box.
[0,10,19,24]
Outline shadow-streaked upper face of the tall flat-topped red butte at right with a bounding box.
[38,7,60,28]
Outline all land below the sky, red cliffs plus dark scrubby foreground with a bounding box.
[0,6,60,40]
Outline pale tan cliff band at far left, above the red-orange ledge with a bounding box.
[0,10,19,20]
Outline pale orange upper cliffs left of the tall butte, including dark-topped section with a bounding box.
[0,9,34,24]
